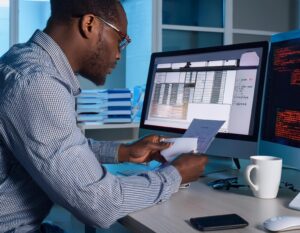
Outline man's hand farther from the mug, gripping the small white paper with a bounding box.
[118,135,171,163]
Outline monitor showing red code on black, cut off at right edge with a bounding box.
[259,31,300,170]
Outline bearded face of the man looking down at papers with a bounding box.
[79,7,127,85]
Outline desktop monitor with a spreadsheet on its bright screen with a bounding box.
[140,42,268,158]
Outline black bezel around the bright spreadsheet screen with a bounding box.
[140,41,269,141]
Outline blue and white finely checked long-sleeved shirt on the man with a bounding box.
[0,31,181,232]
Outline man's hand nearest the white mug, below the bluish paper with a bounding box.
[171,154,207,184]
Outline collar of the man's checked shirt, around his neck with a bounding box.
[30,30,80,95]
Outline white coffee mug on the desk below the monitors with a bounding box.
[245,155,282,199]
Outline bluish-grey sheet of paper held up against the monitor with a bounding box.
[183,119,225,153]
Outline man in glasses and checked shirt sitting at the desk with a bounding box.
[0,0,207,233]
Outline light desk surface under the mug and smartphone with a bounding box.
[120,178,300,233]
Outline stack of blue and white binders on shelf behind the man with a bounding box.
[76,88,132,125]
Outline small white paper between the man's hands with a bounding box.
[160,138,198,162]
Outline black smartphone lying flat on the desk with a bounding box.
[190,214,249,231]
